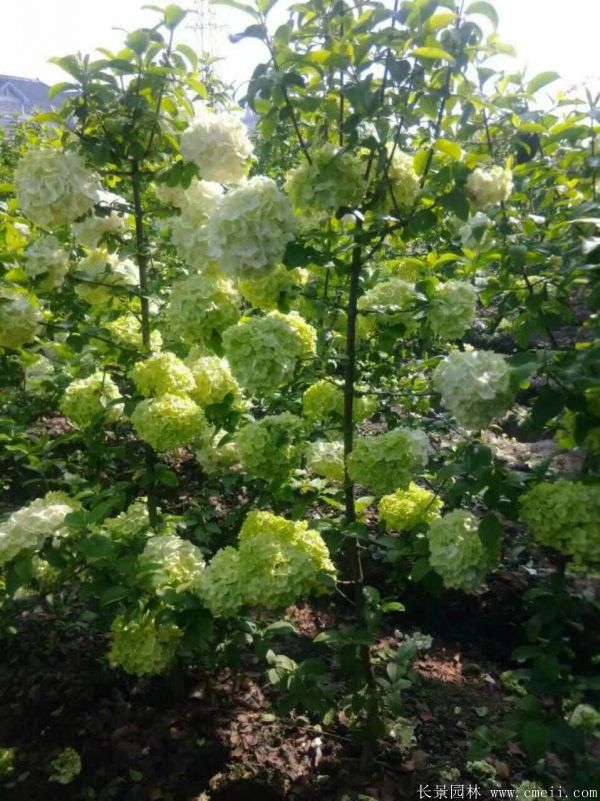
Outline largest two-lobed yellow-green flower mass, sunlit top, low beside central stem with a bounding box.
[201,510,335,617]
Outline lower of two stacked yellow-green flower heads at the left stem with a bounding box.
[131,394,208,453]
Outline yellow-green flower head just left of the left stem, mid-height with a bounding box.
[60,370,123,428]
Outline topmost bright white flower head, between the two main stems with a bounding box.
[181,109,252,184]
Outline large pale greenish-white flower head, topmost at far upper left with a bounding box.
[15,150,99,226]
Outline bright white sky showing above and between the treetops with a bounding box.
[0,0,600,100]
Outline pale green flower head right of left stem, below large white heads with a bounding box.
[166,271,240,342]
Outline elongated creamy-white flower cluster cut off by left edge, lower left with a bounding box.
[0,492,78,565]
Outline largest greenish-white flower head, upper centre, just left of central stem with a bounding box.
[207,176,295,276]
